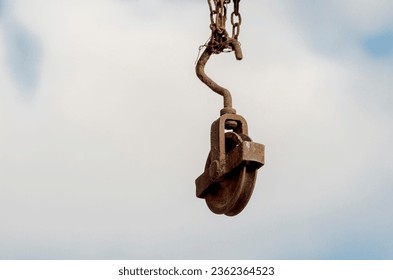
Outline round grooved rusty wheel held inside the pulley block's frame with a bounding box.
[205,132,257,216]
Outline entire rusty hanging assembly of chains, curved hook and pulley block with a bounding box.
[195,0,265,216]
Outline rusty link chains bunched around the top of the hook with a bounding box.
[207,0,242,54]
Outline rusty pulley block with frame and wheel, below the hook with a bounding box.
[195,114,265,216]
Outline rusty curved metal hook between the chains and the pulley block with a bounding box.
[195,40,243,115]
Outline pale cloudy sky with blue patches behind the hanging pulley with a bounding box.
[0,0,393,259]
